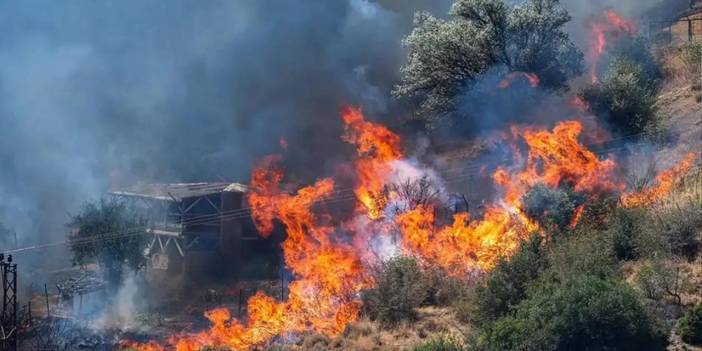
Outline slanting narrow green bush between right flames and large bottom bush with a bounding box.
[470,234,547,325]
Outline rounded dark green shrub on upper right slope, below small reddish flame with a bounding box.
[581,58,658,135]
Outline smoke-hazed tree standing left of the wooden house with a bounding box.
[68,199,147,284]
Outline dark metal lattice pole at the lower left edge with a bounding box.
[0,254,18,351]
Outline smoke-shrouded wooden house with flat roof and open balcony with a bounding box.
[110,182,259,276]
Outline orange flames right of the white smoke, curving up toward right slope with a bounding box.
[396,121,623,276]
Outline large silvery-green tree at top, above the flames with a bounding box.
[394,0,582,125]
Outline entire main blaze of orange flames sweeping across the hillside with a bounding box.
[123,108,693,351]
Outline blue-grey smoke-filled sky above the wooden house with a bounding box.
[0,0,675,250]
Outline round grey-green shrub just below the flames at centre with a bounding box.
[361,257,429,325]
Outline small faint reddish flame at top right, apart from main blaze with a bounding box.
[588,9,638,83]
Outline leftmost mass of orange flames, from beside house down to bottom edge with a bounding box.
[132,157,369,351]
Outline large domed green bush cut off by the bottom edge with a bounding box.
[478,275,667,350]
